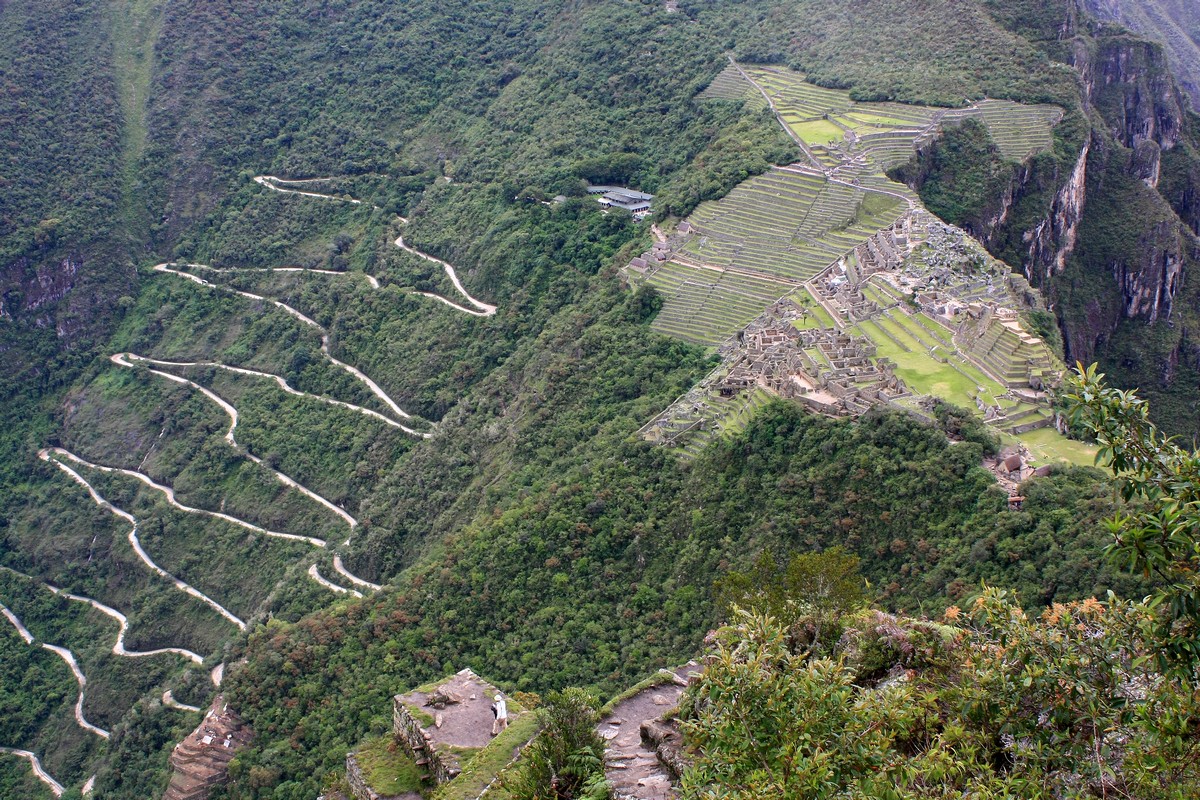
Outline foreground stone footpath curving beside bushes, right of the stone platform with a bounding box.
[596,667,689,800]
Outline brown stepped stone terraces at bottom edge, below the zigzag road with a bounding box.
[162,694,254,800]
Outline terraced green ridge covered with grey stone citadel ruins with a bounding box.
[626,62,1062,453]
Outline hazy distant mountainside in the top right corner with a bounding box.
[1084,0,1200,108]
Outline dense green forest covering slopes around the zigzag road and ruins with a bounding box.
[0,0,1194,800]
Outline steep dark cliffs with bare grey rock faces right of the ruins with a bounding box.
[900,0,1200,437]
